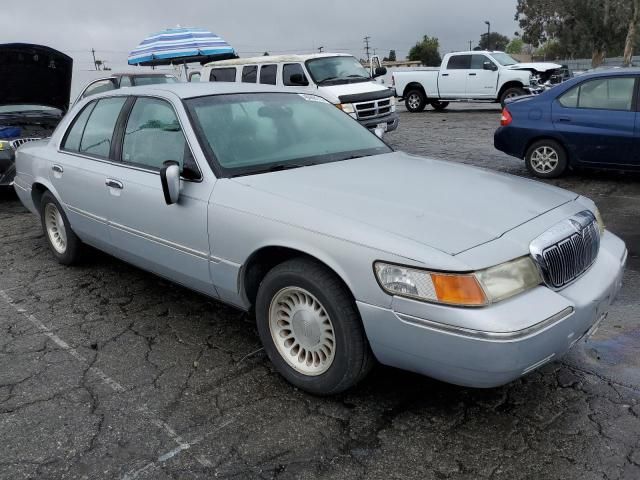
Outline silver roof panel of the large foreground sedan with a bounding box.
[87,82,304,99]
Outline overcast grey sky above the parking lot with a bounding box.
[5,0,517,69]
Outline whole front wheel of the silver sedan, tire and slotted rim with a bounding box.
[256,258,373,395]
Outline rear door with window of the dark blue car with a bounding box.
[552,76,638,167]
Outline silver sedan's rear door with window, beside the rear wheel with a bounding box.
[49,96,127,249]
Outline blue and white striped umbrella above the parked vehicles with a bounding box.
[128,27,236,66]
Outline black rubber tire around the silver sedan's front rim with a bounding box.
[256,258,374,395]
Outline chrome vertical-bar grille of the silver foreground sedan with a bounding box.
[530,210,600,289]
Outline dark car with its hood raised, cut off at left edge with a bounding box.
[0,43,73,188]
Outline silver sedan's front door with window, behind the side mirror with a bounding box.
[106,97,216,296]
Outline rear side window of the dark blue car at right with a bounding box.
[559,77,636,111]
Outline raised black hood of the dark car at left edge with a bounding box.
[0,43,73,111]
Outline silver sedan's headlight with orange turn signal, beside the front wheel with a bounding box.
[374,256,542,307]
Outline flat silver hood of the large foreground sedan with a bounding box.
[234,152,578,255]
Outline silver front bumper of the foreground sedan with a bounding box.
[358,232,627,388]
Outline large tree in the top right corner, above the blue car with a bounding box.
[515,0,639,67]
